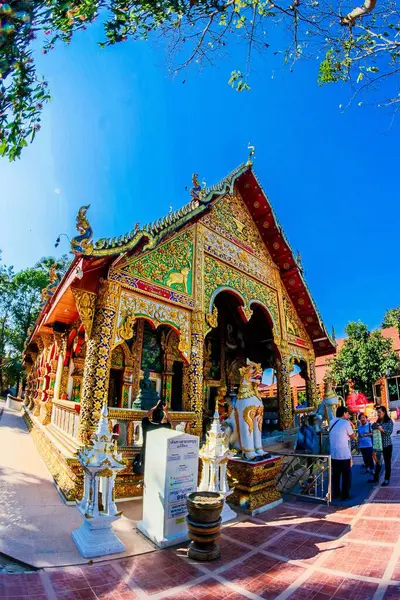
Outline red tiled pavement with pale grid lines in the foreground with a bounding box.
[0,404,400,600]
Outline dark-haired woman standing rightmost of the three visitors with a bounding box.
[370,406,393,487]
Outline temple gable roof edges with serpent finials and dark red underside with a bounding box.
[25,160,335,356]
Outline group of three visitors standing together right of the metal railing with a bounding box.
[329,406,393,500]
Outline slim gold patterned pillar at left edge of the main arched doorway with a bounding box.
[188,310,205,435]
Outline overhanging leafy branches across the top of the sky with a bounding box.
[0,0,400,160]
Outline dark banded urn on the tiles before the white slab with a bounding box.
[186,492,224,561]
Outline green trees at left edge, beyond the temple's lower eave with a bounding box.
[0,256,70,392]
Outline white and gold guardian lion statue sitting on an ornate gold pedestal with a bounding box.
[224,360,265,460]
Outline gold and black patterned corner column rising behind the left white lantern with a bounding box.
[78,280,121,442]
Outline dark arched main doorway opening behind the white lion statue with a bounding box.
[203,291,278,431]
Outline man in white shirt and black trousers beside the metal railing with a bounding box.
[329,406,355,500]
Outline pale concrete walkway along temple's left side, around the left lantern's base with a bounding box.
[0,402,155,568]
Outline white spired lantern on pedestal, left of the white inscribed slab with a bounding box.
[72,405,125,558]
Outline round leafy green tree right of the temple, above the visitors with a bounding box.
[330,321,398,397]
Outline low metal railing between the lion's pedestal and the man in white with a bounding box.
[274,452,332,504]
